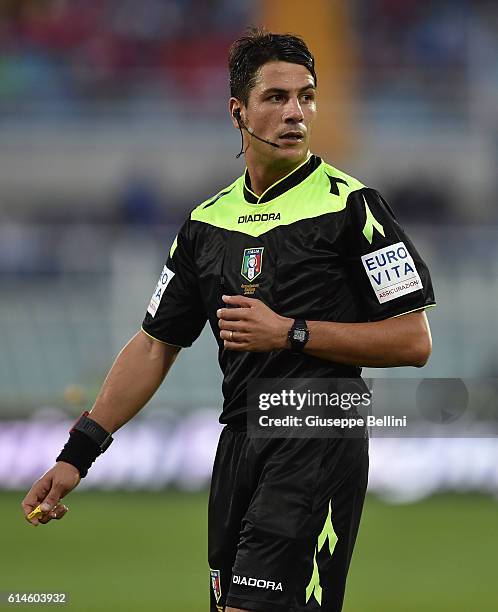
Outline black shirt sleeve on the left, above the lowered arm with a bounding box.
[142,220,207,347]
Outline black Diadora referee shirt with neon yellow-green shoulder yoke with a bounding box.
[142,155,435,423]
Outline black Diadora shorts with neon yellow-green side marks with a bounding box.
[209,426,368,612]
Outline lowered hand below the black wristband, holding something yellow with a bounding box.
[21,461,81,526]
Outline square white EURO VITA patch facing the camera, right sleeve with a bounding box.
[361,242,423,304]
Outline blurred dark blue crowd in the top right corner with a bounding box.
[355,0,498,114]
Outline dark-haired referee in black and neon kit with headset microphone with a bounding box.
[22,30,434,612]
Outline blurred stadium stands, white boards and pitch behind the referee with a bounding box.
[0,0,498,612]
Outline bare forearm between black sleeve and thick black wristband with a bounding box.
[89,331,180,433]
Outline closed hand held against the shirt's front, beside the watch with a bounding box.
[216,295,293,353]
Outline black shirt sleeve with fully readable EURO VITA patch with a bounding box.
[343,188,435,321]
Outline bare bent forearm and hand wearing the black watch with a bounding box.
[218,295,432,368]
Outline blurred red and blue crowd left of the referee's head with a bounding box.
[0,0,251,113]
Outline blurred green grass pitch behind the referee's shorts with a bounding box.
[0,492,498,612]
